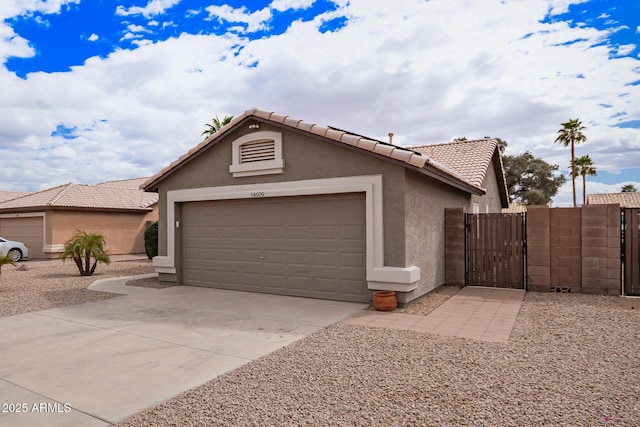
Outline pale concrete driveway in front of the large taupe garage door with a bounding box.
[0,278,366,426]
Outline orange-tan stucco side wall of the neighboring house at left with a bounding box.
[46,209,158,257]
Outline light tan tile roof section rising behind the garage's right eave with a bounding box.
[411,139,498,187]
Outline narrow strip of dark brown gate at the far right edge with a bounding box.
[622,208,640,295]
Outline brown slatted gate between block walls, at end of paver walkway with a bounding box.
[465,213,527,289]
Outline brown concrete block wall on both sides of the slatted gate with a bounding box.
[445,205,622,295]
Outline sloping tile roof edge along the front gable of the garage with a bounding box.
[143,108,487,194]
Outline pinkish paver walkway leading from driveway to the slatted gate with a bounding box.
[344,287,525,342]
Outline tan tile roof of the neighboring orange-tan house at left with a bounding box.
[0,183,158,212]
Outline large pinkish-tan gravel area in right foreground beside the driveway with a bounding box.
[118,293,640,426]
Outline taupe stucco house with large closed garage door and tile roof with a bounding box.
[142,109,508,303]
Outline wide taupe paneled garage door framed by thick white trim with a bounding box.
[181,193,369,302]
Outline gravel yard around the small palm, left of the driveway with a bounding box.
[0,260,153,317]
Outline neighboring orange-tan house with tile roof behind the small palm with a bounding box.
[0,178,158,259]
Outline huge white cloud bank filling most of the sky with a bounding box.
[0,0,640,201]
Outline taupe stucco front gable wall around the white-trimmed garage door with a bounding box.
[158,124,407,278]
